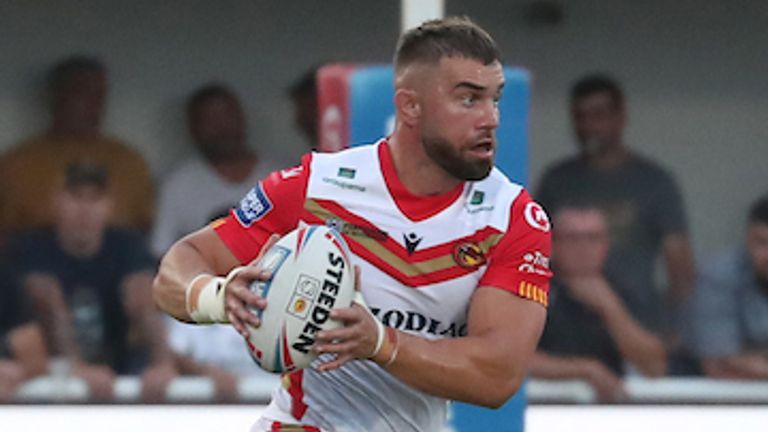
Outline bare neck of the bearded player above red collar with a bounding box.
[388,130,461,195]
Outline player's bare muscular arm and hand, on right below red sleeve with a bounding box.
[317,287,546,407]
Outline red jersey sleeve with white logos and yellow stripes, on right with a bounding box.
[479,190,552,306]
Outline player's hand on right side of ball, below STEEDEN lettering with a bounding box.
[313,267,378,372]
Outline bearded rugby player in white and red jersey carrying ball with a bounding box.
[155,18,551,432]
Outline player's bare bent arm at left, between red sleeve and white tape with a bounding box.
[153,227,240,322]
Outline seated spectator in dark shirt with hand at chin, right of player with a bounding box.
[529,206,666,402]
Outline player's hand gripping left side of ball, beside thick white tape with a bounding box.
[224,234,280,337]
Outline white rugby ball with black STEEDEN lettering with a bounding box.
[246,225,355,373]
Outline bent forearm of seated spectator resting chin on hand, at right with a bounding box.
[600,301,667,377]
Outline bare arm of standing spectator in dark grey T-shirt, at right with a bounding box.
[662,233,696,305]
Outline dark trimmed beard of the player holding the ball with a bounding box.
[421,136,495,181]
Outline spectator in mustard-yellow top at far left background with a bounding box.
[0,56,154,233]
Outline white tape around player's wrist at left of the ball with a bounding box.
[186,267,245,324]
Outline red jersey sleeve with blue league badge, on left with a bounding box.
[211,154,312,264]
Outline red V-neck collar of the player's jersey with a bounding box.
[378,140,464,222]
